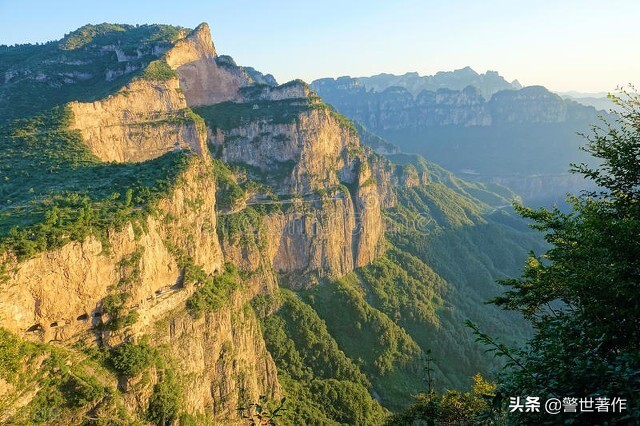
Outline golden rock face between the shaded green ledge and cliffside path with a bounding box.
[0,158,223,342]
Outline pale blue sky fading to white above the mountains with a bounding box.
[0,0,640,92]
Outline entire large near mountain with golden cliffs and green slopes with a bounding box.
[0,24,544,425]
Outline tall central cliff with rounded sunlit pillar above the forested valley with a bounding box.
[205,88,383,287]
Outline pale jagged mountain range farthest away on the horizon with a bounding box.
[340,67,522,99]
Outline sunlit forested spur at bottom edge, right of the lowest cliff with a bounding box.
[254,290,387,425]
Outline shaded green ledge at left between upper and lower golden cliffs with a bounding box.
[0,107,191,259]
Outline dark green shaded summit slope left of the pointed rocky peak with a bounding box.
[0,24,186,120]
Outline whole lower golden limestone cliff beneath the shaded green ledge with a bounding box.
[0,147,280,421]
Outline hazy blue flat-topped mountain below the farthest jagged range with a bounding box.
[312,78,603,204]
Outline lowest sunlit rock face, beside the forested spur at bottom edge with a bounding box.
[157,292,280,419]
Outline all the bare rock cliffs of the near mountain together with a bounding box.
[0,24,388,423]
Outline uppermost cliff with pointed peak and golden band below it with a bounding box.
[70,24,250,162]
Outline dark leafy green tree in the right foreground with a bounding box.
[484,90,640,424]
